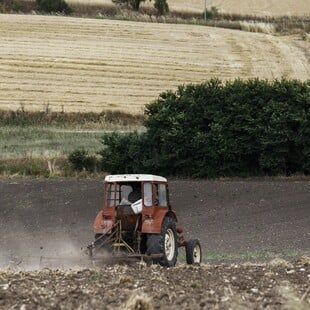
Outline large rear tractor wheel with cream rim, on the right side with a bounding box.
[147,217,178,267]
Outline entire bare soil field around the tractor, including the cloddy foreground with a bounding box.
[0,179,310,309]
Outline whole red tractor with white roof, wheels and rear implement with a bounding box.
[88,174,202,267]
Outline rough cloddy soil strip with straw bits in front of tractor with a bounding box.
[0,259,310,310]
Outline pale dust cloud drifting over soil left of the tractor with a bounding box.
[0,226,92,270]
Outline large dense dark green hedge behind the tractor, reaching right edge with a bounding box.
[101,79,310,177]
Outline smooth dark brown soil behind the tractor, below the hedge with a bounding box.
[0,179,310,263]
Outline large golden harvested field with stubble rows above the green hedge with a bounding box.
[0,14,310,113]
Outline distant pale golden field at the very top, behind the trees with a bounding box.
[67,0,310,16]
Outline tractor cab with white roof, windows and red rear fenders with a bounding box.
[94,174,177,234]
